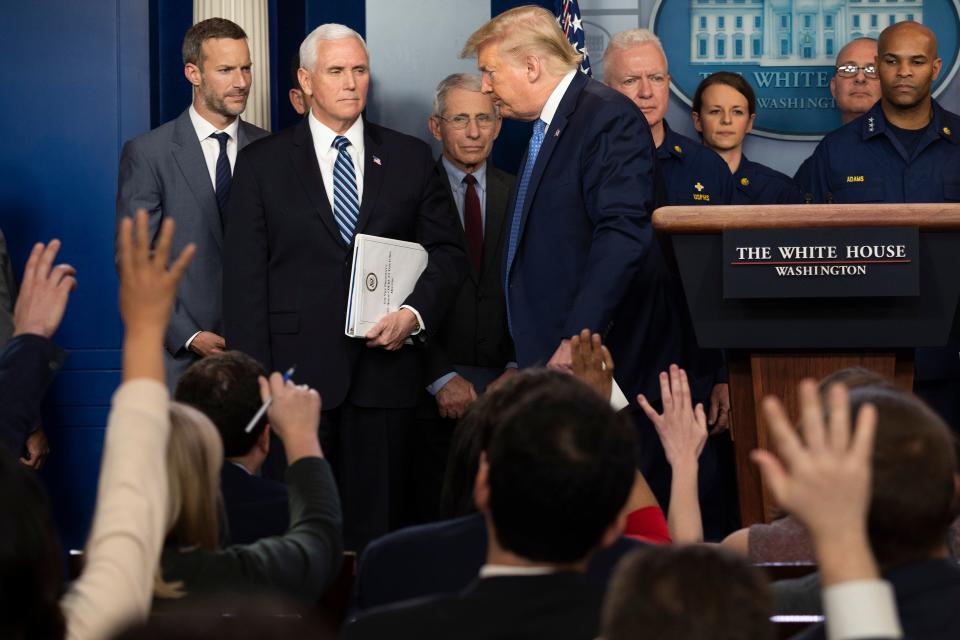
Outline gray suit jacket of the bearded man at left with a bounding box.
[117,109,268,389]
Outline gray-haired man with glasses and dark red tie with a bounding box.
[413,73,516,520]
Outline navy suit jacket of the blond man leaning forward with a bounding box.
[505,73,655,397]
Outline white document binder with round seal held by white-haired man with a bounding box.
[344,233,427,338]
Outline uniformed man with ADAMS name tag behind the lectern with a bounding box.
[811,22,960,430]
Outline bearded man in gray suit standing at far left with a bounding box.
[117,18,268,389]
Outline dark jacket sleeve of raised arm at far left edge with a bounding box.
[0,333,67,456]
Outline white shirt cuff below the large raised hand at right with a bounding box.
[822,579,903,640]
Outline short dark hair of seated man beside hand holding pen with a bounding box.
[174,351,267,458]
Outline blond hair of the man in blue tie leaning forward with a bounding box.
[460,5,583,75]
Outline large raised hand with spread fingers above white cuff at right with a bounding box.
[751,380,877,586]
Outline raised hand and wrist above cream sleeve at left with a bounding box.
[117,209,196,381]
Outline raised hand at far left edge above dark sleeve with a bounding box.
[13,239,77,338]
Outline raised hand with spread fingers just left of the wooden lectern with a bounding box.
[637,364,707,467]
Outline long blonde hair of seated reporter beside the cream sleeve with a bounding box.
[153,402,223,598]
